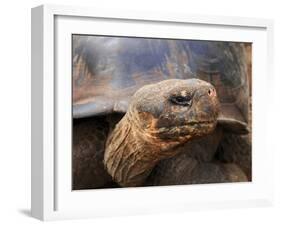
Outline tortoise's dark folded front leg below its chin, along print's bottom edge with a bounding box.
[147,153,248,186]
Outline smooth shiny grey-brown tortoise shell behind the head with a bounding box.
[72,35,249,133]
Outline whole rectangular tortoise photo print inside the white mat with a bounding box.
[72,35,251,189]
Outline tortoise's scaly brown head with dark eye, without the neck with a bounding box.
[128,79,219,141]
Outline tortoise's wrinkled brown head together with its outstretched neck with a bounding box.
[104,79,222,186]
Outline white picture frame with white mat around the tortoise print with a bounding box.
[31,5,273,220]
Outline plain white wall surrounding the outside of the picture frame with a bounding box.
[0,0,281,226]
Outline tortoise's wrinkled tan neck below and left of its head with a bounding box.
[104,114,180,187]
